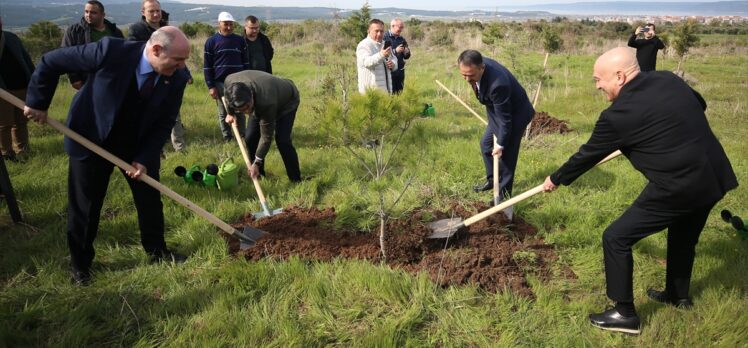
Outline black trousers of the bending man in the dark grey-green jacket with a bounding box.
[244,104,301,181]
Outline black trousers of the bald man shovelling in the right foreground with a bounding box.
[603,202,716,302]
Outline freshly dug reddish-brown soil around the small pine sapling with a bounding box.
[229,204,575,297]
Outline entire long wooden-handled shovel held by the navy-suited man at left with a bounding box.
[0,89,267,250]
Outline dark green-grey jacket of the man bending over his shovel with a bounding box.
[224,70,299,158]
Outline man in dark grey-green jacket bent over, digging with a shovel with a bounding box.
[224,70,301,182]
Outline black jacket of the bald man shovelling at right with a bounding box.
[551,71,738,212]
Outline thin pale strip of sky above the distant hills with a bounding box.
[178,0,719,10]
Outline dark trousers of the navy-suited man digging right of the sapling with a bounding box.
[480,127,522,200]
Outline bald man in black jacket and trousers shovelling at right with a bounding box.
[543,47,738,334]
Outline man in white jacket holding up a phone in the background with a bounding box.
[356,18,397,94]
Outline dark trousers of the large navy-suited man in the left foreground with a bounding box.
[67,155,166,271]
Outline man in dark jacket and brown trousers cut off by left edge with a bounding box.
[0,18,34,161]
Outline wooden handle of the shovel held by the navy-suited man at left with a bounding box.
[0,89,236,234]
